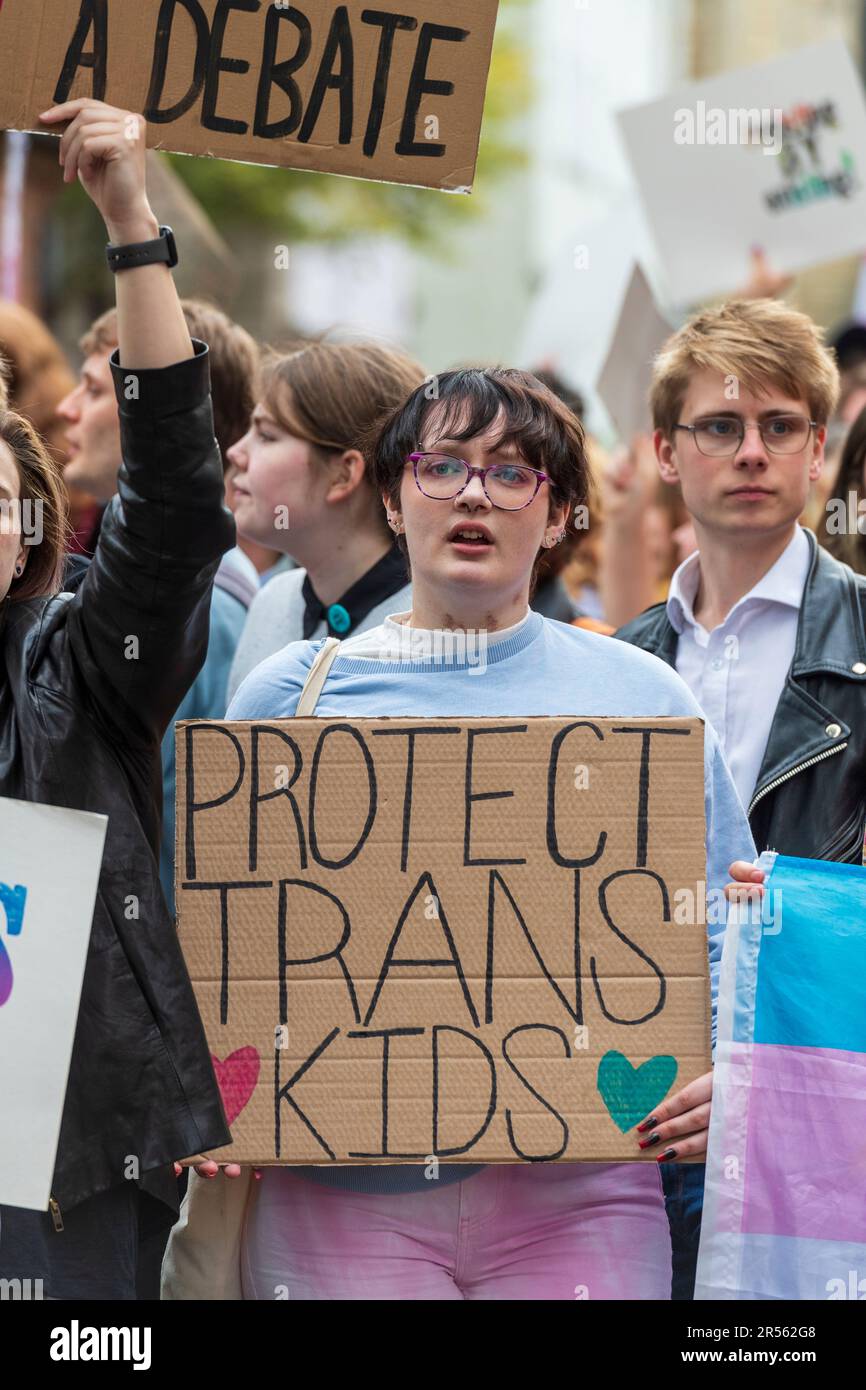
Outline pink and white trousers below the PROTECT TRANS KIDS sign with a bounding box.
[242,1163,670,1301]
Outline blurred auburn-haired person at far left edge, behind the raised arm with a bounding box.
[0,300,101,555]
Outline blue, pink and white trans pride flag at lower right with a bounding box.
[695,853,866,1300]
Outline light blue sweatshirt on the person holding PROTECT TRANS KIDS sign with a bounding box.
[227,613,755,1193]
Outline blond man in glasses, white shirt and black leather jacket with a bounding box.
[617,299,866,1298]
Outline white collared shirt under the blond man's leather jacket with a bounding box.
[667,525,810,809]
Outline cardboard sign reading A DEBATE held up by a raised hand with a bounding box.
[0,0,498,192]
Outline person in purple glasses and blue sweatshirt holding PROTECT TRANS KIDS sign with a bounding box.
[167,370,753,1300]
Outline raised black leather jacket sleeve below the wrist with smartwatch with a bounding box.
[67,342,235,742]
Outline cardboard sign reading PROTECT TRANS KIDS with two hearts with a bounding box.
[177,717,710,1163]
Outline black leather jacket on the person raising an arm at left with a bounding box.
[0,343,235,1211]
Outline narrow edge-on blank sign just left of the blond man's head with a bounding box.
[596,265,671,443]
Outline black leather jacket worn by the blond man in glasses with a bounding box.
[616,531,866,863]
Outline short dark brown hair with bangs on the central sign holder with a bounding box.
[367,367,589,549]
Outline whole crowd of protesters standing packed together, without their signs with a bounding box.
[0,2,866,1323]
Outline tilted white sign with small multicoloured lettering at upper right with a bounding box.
[619,40,866,304]
